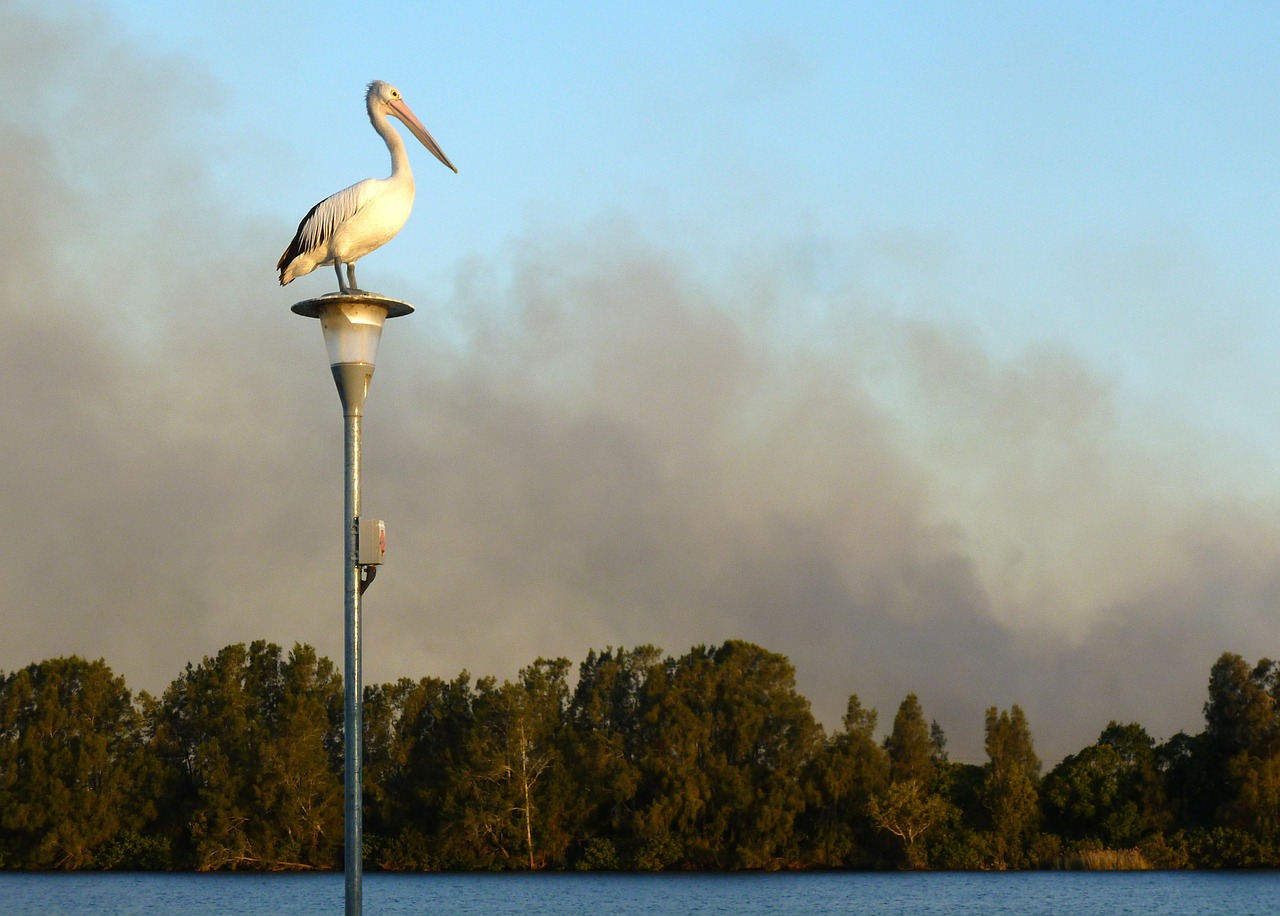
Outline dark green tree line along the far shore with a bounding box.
[0,641,1280,870]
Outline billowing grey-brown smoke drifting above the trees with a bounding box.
[0,6,1280,761]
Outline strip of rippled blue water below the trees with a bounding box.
[0,871,1280,916]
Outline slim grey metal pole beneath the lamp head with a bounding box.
[342,407,364,916]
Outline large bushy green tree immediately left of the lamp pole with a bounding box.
[151,641,343,870]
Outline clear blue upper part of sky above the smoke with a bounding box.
[106,3,1280,419]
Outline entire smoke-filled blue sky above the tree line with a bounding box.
[0,0,1280,765]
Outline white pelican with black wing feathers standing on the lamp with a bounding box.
[275,79,457,293]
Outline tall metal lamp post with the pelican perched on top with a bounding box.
[293,293,413,916]
